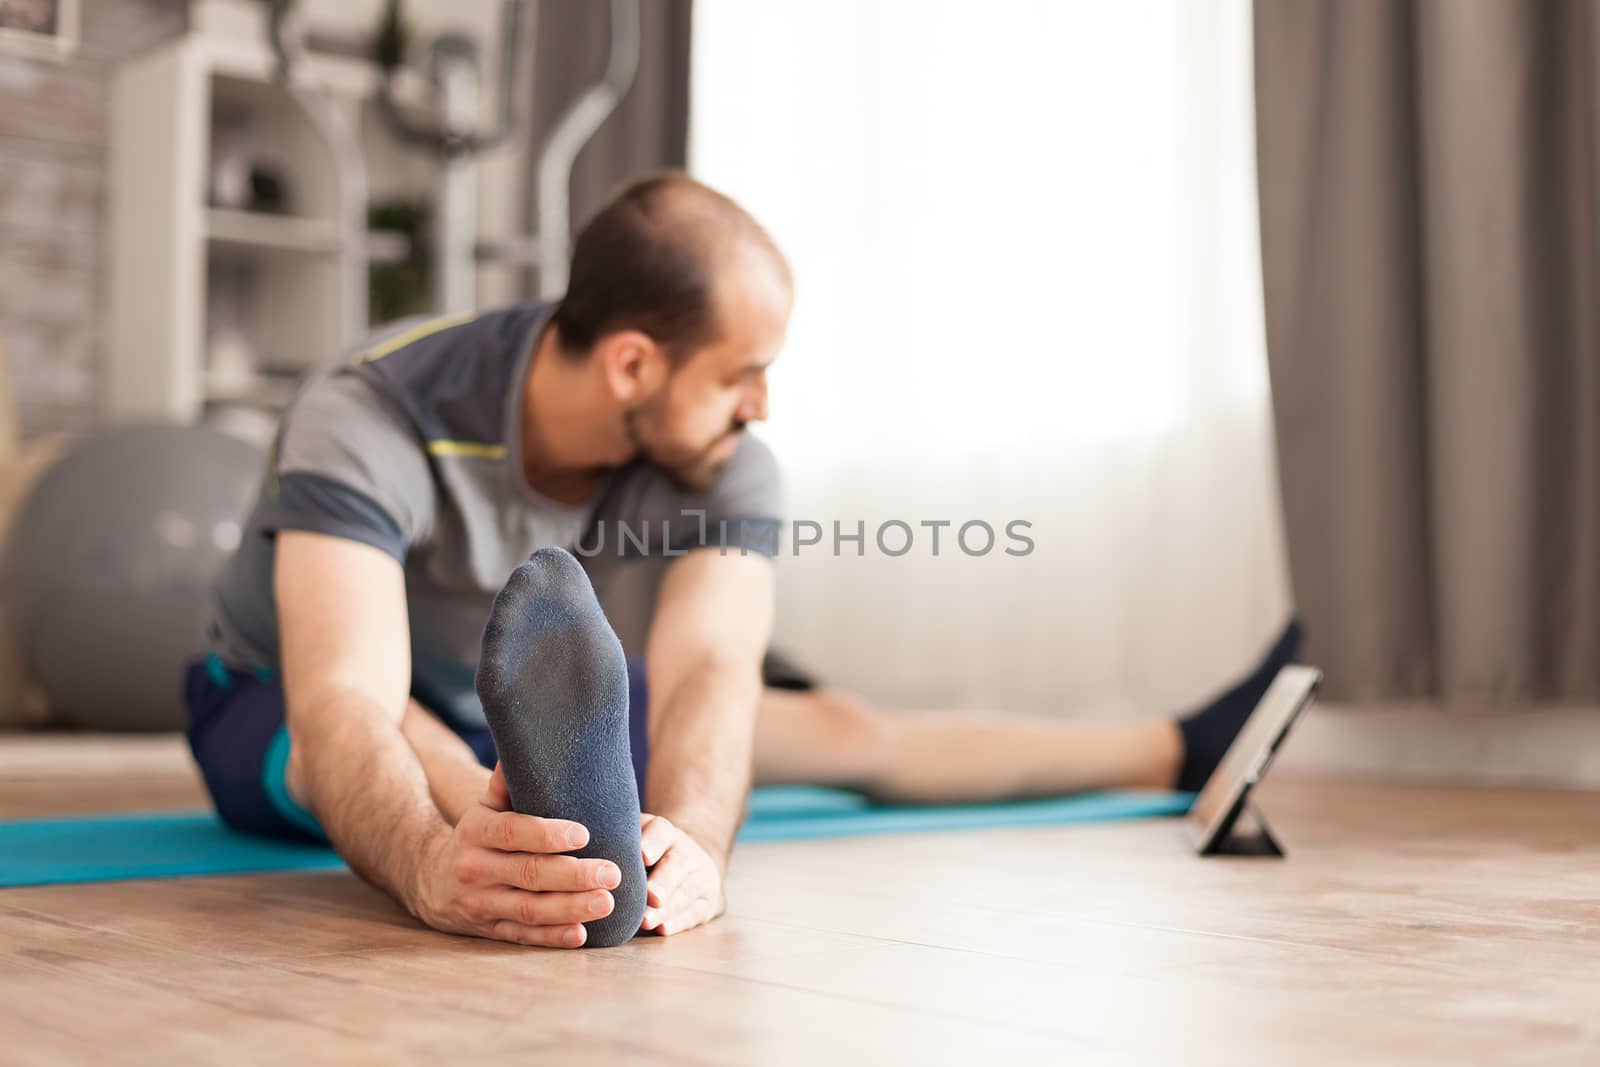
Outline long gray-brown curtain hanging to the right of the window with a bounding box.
[1254,0,1600,705]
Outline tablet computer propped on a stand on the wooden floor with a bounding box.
[1189,664,1322,856]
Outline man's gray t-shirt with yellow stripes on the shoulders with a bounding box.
[211,304,779,726]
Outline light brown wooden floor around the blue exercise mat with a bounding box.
[0,741,1600,1065]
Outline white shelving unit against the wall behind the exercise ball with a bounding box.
[106,34,388,422]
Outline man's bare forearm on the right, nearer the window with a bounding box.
[645,549,774,933]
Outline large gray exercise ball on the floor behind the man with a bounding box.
[0,426,264,731]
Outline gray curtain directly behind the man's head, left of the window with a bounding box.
[525,0,693,271]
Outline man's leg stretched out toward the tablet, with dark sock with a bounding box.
[755,622,1301,803]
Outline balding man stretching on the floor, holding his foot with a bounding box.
[187,174,1298,947]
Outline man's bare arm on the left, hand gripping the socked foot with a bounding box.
[275,531,621,947]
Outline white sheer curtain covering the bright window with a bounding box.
[690,0,1288,713]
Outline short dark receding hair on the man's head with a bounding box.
[555,171,789,362]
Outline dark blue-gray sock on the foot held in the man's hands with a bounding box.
[478,549,645,949]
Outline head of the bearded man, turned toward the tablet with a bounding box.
[555,173,794,488]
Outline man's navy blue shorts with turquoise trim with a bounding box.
[184,656,650,841]
